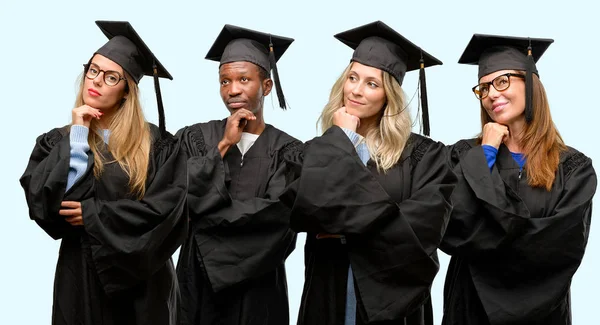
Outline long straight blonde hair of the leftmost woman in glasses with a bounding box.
[75,73,152,199]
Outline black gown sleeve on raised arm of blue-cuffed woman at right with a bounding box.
[441,141,529,256]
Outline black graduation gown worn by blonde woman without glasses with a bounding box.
[281,126,456,325]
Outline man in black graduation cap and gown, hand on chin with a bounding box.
[177,25,301,325]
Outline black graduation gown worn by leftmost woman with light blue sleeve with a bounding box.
[20,125,187,325]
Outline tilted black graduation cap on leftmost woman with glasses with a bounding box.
[95,20,173,136]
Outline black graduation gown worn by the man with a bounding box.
[177,120,301,325]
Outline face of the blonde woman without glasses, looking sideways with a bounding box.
[344,62,386,123]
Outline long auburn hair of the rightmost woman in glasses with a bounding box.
[478,74,567,191]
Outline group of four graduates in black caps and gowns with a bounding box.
[20,21,596,325]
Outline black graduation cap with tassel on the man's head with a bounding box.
[206,24,294,109]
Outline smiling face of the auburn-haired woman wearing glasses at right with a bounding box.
[479,70,525,125]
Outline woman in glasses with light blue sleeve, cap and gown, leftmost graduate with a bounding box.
[20,21,187,325]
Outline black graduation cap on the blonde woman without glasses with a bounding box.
[334,21,442,136]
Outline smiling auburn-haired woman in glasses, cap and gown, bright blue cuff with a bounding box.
[441,34,596,325]
